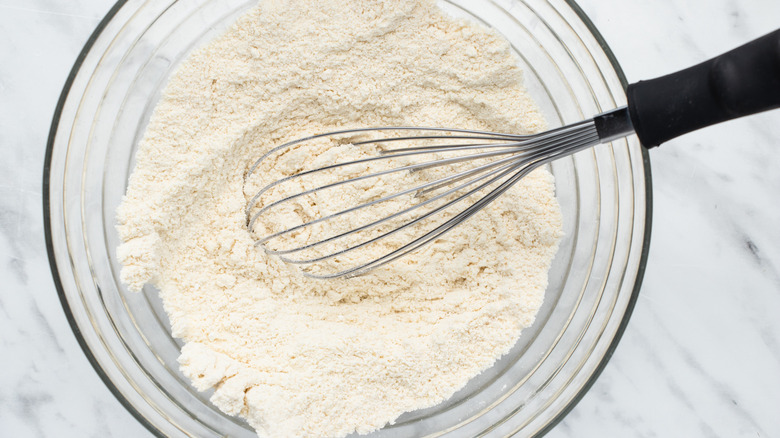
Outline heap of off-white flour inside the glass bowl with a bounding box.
[118,0,561,437]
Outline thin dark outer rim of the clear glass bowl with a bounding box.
[41,0,653,438]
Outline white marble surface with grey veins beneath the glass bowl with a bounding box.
[0,0,780,438]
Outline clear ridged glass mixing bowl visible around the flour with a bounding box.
[44,0,651,437]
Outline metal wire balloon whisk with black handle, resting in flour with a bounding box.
[244,30,780,279]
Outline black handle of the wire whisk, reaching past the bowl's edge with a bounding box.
[627,30,780,147]
